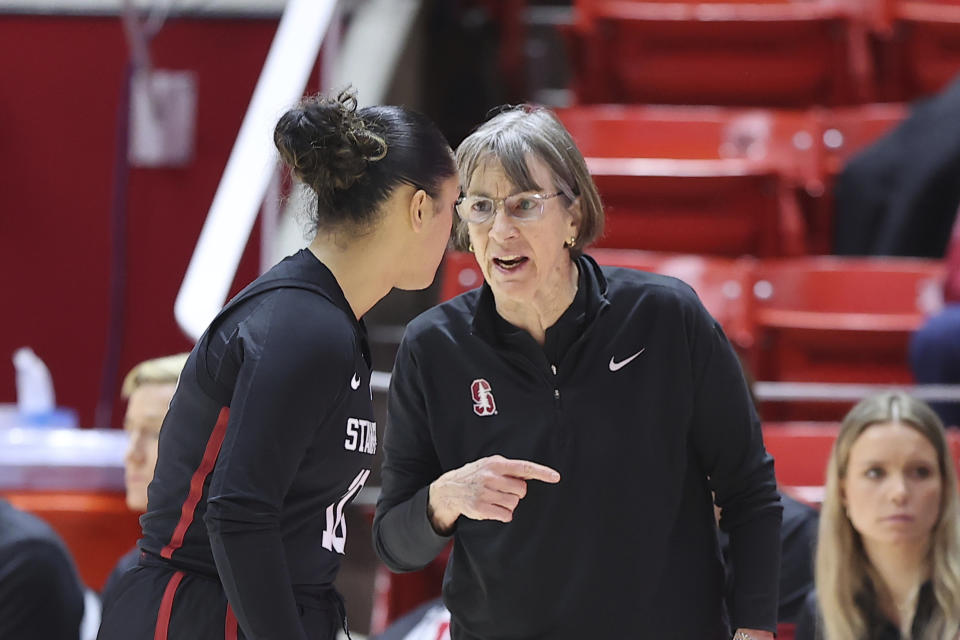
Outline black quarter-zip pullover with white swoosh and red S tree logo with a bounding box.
[374,256,781,640]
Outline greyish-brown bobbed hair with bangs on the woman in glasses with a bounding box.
[454,104,604,257]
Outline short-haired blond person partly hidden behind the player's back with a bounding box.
[103,353,189,599]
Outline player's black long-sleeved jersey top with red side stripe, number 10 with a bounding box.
[140,250,377,640]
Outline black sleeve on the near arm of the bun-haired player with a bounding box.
[206,291,353,640]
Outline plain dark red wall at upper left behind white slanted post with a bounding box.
[0,16,316,426]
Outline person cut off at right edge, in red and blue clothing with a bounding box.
[910,208,960,427]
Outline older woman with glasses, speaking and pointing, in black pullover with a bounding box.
[374,106,781,640]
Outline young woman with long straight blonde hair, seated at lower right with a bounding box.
[797,392,960,640]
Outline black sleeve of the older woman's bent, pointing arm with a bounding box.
[373,338,450,571]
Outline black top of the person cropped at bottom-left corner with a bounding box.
[0,498,83,640]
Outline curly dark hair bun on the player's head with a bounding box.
[273,88,387,206]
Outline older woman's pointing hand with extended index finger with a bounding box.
[427,456,560,535]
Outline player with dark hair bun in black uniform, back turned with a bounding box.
[99,91,459,640]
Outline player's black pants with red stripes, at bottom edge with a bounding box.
[97,564,345,640]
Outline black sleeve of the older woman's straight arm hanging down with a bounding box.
[691,307,782,631]
